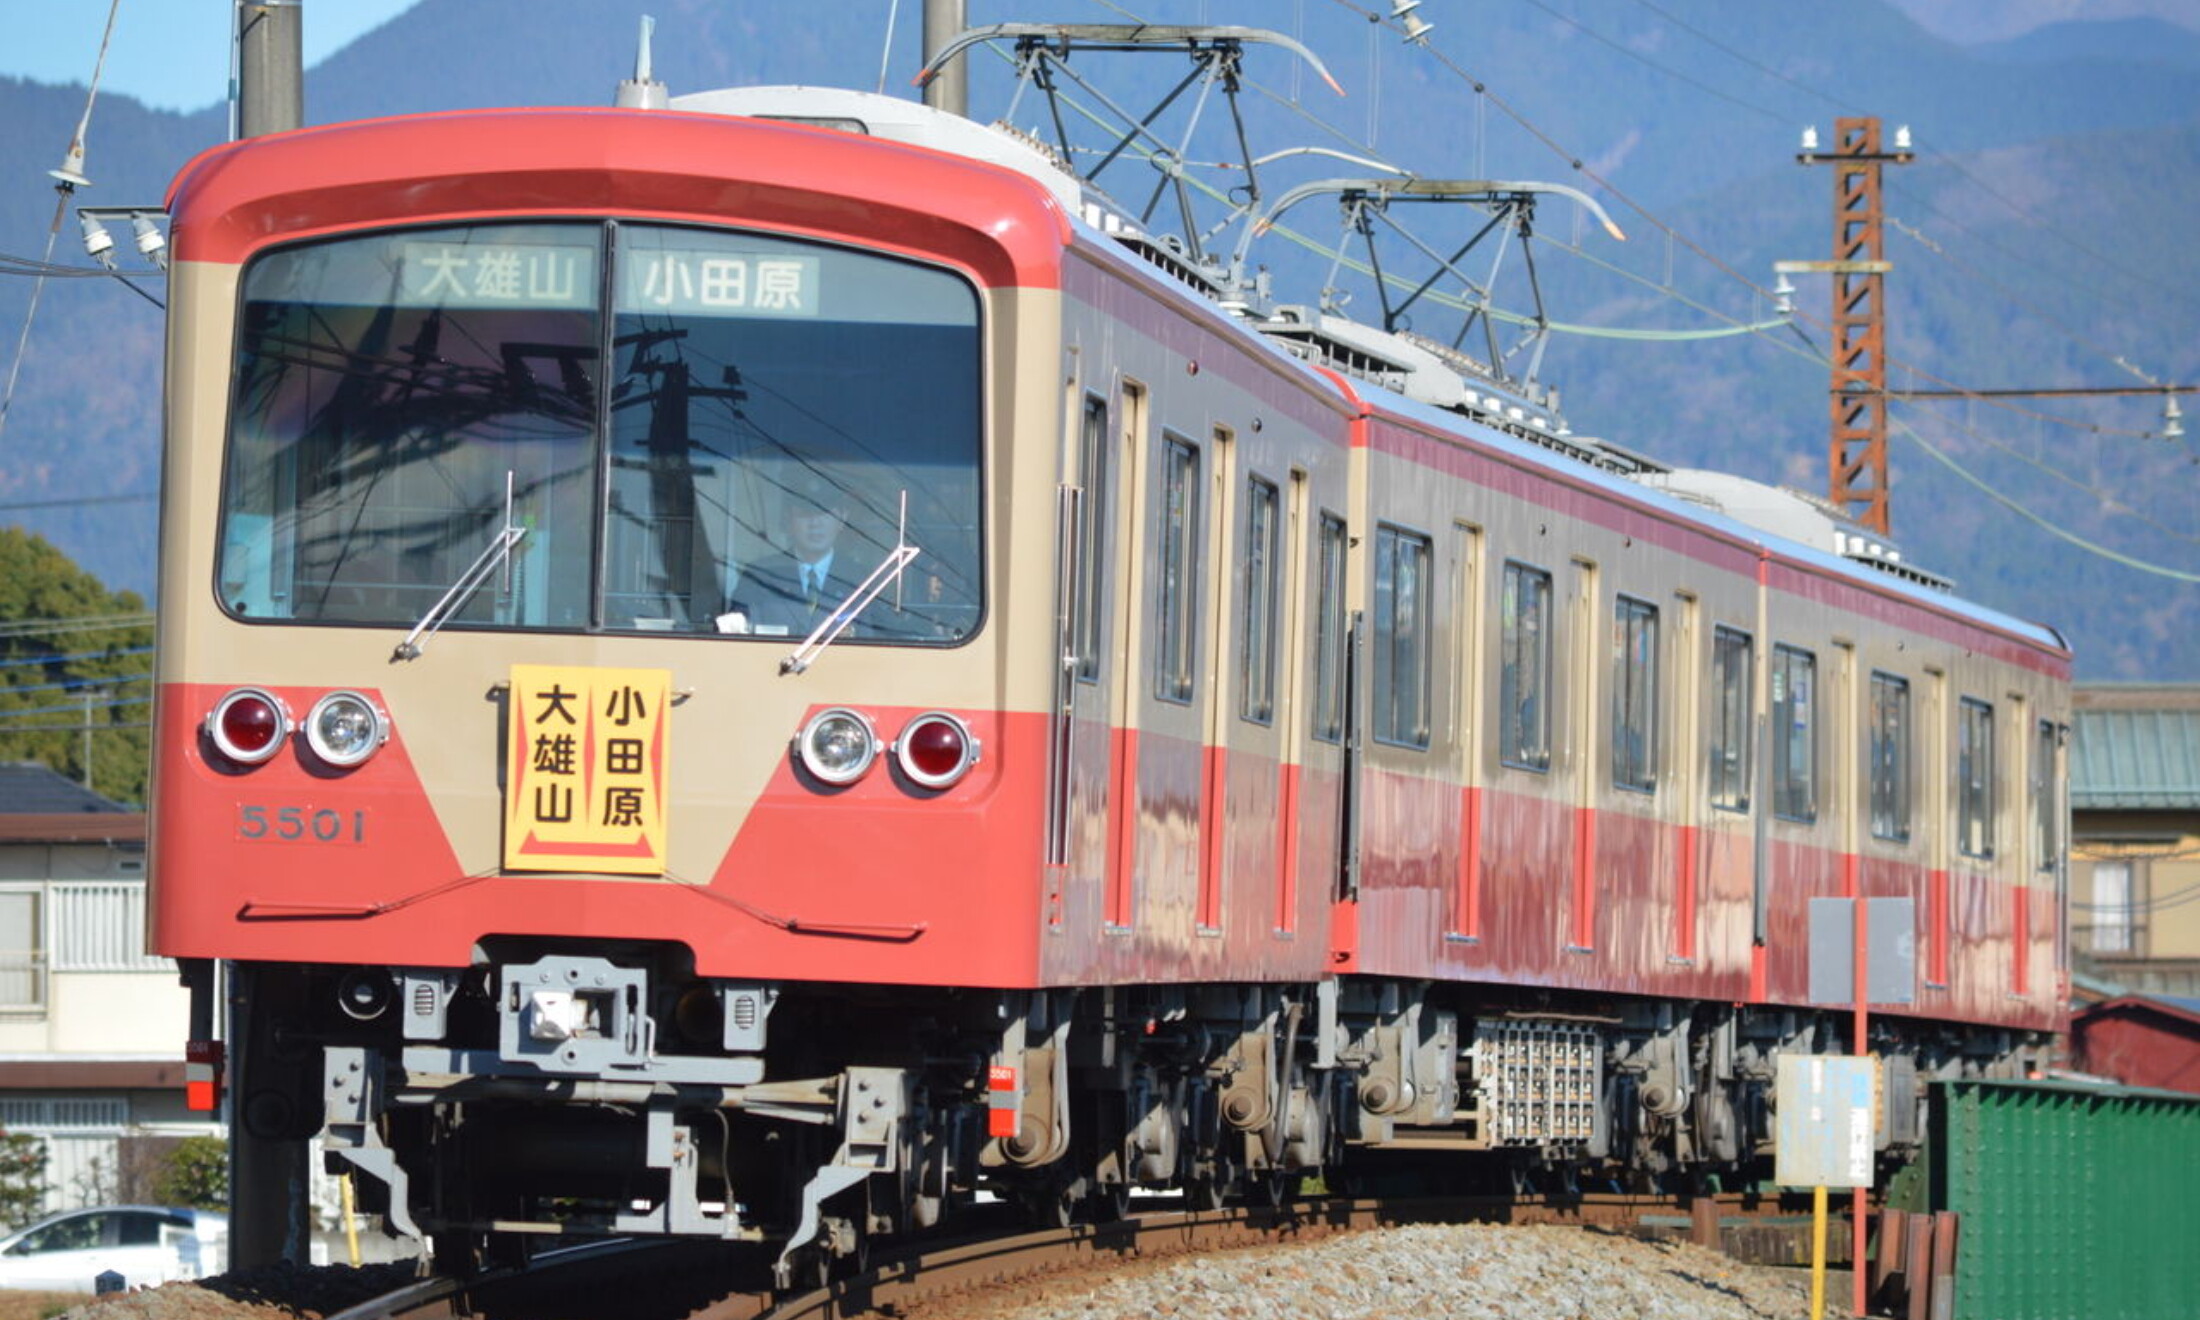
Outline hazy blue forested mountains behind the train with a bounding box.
[0,0,2200,680]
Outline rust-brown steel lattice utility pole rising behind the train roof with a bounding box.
[1778,117,1916,535]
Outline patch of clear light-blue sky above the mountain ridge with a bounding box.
[0,0,420,110]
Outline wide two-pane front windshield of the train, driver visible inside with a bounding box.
[218,224,983,645]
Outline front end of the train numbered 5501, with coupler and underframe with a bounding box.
[154,110,1067,1252]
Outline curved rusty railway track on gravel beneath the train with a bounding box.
[330,1195,1830,1320]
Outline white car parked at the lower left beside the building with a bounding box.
[0,1206,229,1294]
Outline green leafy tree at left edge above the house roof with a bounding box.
[0,528,152,805]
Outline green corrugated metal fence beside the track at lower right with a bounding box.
[1932,1082,2200,1320]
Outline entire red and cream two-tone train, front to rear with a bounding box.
[152,30,2070,1276]
